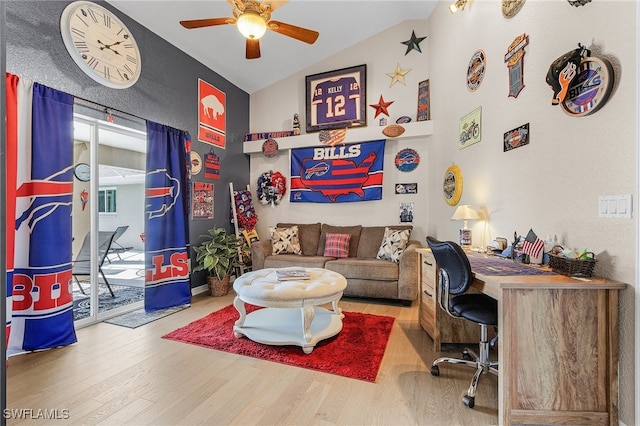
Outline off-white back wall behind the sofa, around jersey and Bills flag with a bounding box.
[250,20,430,242]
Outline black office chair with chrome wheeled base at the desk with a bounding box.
[427,237,498,408]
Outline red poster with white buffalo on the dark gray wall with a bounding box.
[198,79,227,149]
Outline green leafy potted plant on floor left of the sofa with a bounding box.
[193,227,240,296]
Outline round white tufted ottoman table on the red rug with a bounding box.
[233,268,347,354]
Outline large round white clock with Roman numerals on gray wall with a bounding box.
[60,1,142,89]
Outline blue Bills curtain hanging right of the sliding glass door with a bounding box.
[144,121,191,312]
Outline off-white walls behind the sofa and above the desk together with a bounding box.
[250,0,638,425]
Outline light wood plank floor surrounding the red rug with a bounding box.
[7,293,498,425]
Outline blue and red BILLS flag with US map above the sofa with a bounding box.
[289,140,385,203]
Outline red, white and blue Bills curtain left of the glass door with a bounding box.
[6,75,77,356]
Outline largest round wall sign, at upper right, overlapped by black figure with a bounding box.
[562,56,614,117]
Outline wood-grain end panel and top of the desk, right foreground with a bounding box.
[418,248,626,425]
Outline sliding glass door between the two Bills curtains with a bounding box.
[73,116,146,326]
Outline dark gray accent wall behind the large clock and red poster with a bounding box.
[1,1,249,287]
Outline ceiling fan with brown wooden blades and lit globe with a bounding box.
[180,0,319,59]
